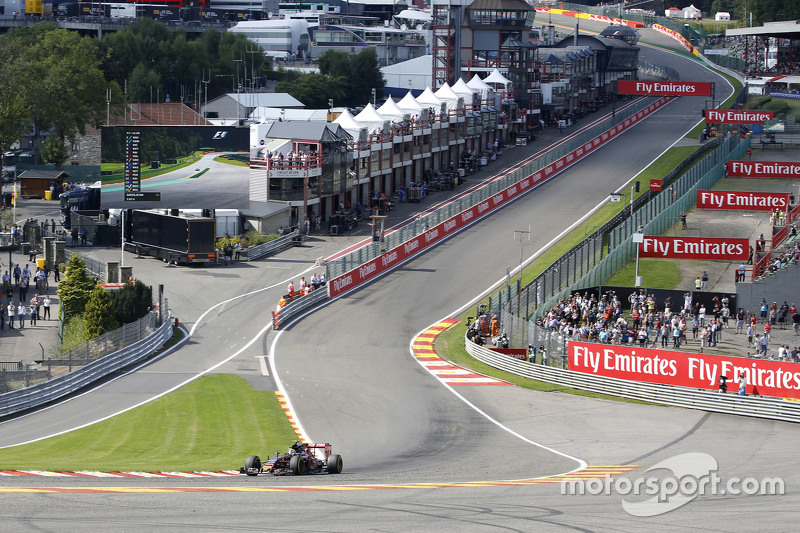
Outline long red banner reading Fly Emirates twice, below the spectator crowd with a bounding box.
[569,341,800,398]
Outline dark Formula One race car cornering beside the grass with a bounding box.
[239,441,342,476]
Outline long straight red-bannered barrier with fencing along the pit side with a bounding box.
[328,97,672,297]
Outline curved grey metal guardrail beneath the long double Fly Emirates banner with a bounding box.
[464,339,800,423]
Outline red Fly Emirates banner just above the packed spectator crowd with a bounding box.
[639,236,750,261]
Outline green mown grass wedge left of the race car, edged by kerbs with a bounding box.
[0,374,297,472]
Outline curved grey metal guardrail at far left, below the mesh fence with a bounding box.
[0,310,172,417]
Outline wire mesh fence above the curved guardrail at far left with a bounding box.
[0,299,169,393]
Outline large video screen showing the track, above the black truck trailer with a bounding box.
[101,126,250,209]
